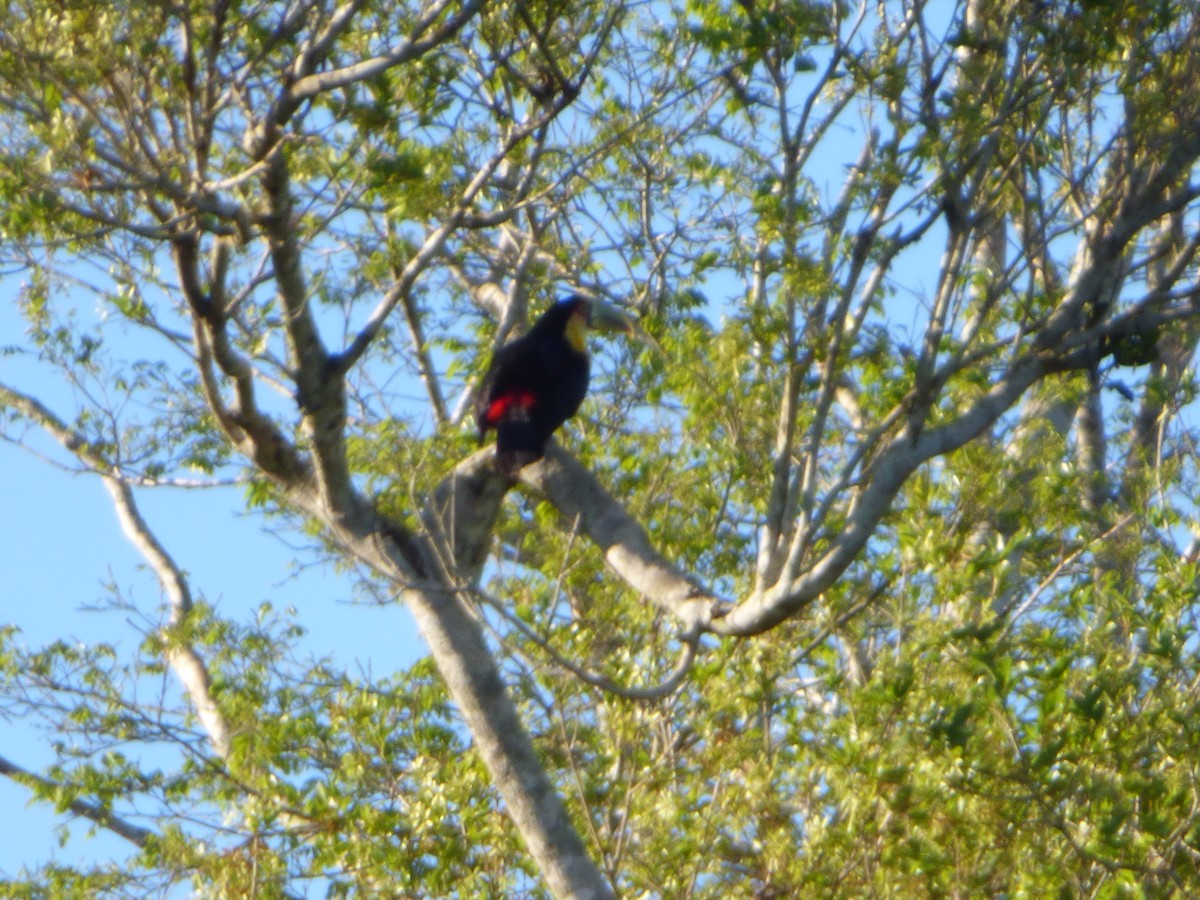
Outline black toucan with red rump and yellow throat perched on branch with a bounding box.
[475,294,652,475]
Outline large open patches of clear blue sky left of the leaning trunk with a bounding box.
[0,294,424,876]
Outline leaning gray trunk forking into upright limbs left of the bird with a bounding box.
[174,4,611,898]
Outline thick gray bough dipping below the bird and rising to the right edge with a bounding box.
[521,150,1200,635]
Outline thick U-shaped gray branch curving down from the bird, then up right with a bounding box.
[522,134,1200,635]
